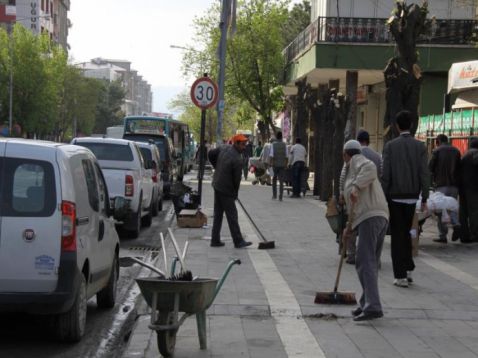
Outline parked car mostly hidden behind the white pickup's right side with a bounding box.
[137,142,163,216]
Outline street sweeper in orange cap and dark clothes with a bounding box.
[209,134,252,249]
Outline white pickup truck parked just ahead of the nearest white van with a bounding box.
[72,137,154,238]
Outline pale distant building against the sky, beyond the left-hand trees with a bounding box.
[76,58,153,116]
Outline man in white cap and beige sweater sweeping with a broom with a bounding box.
[343,140,389,321]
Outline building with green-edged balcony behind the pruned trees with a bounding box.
[284,0,478,150]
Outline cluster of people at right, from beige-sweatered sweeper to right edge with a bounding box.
[339,111,478,321]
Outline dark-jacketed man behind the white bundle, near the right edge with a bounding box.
[428,134,461,244]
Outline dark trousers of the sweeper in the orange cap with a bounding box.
[211,190,244,245]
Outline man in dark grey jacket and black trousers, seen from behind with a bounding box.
[382,111,429,287]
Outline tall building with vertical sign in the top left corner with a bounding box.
[0,0,70,51]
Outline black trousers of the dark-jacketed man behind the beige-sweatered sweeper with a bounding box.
[388,201,416,278]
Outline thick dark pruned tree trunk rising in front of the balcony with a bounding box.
[384,0,430,142]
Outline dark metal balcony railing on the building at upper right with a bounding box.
[284,17,478,63]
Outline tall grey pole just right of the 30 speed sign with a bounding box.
[216,0,231,144]
